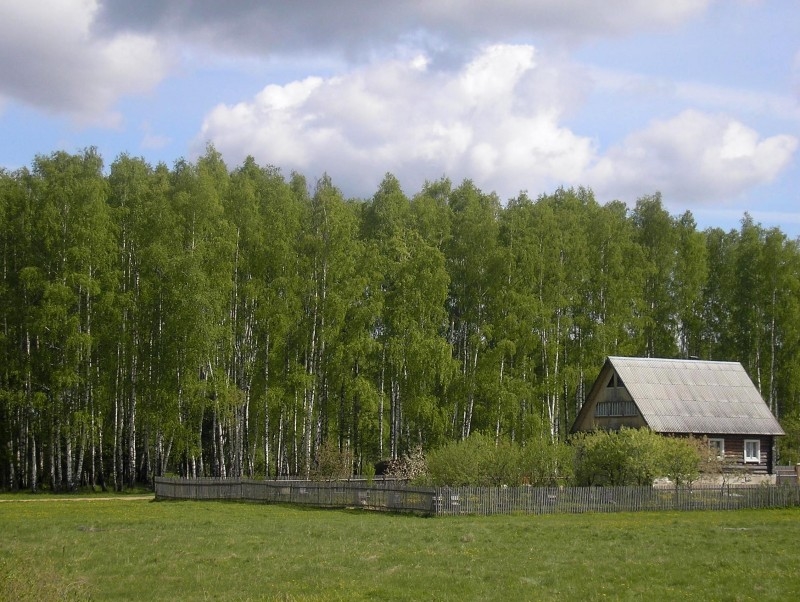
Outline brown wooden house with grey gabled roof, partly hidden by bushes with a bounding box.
[572,357,785,474]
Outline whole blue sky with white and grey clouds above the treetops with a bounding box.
[0,0,800,238]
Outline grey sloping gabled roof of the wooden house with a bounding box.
[581,357,784,435]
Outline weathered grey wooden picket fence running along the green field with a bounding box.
[155,478,800,516]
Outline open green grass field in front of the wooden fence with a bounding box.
[0,496,800,602]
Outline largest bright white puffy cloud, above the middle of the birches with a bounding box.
[197,45,595,196]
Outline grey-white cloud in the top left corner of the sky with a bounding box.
[0,0,166,125]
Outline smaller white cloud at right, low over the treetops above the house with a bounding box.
[587,109,798,203]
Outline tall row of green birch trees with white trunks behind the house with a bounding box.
[0,147,800,490]
